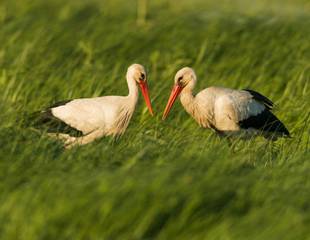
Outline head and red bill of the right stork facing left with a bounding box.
[163,67,197,120]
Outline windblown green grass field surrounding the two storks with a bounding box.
[0,0,310,240]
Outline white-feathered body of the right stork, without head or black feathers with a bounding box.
[180,87,266,137]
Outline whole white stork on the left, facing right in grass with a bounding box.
[32,64,153,148]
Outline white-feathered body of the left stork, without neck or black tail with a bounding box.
[51,94,138,146]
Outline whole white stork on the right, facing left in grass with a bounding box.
[163,67,289,140]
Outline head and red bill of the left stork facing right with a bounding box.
[127,63,154,116]
